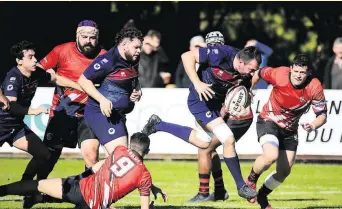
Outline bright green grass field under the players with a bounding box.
[0,159,342,209]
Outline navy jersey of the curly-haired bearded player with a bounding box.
[83,48,139,112]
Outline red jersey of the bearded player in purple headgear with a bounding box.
[40,42,106,116]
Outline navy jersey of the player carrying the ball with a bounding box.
[198,45,251,99]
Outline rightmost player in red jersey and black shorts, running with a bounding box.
[246,54,327,209]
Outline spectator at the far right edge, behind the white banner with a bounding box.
[323,37,342,89]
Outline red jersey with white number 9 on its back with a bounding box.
[80,146,152,209]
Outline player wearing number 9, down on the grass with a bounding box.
[0,133,167,209]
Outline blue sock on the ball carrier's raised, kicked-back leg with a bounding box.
[156,121,192,142]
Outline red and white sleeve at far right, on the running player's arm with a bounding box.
[311,80,328,116]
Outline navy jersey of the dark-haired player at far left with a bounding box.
[0,67,51,130]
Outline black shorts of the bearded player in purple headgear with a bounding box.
[44,112,96,148]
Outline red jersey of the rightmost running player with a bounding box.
[259,67,327,131]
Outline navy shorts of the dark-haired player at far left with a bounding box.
[0,124,34,147]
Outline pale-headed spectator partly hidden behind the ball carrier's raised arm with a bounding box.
[175,36,206,88]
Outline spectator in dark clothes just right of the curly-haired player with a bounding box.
[139,30,171,88]
